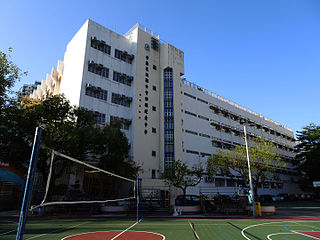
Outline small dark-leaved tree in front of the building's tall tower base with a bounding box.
[162,160,204,202]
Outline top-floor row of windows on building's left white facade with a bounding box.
[91,37,134,64]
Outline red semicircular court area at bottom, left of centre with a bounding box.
[61,231,165,240]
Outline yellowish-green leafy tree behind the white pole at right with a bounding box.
[207,138,286,196]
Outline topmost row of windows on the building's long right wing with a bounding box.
[184,92,295,142]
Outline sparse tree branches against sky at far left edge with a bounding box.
[0,48,27,109]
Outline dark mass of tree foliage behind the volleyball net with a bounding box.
[0,95,137,177]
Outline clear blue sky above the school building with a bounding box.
[0,0,320,136]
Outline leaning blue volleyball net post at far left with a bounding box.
[16,127,42,240]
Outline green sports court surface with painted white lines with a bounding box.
[0,219,320,240]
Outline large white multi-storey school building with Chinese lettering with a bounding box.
[32,20,296,198]
